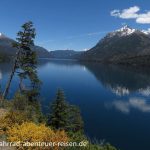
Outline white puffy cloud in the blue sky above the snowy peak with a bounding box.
[110,6,150,24]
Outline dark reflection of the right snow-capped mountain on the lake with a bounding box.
[85,63,150,96]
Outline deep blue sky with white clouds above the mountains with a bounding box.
[0,0,150,51]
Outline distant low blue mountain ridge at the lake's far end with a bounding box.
[50,50,82,59]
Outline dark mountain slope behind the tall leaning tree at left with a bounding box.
[0,33,50,60]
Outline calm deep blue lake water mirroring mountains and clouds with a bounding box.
[0,59,150,150]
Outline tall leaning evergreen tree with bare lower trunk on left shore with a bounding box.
[3,21,40,98]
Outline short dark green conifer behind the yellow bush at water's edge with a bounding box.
[48,89,83,132]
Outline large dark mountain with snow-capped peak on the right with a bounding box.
[81,26,150,65]
